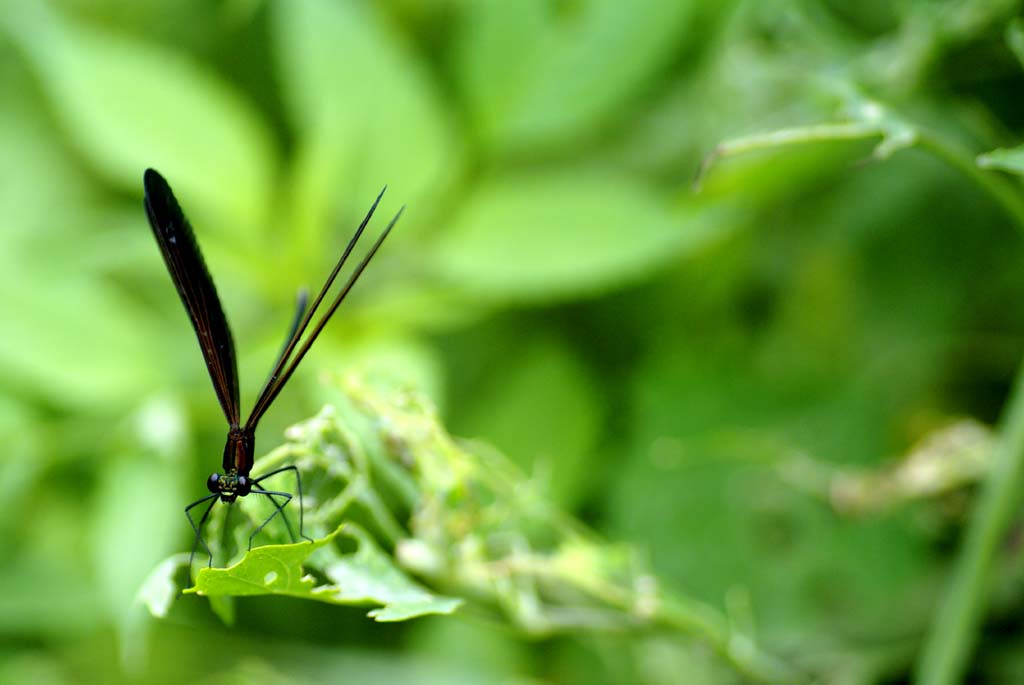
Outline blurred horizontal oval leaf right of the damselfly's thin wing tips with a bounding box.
[432,171,728,301]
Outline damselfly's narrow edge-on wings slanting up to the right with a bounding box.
[245,190,406,433]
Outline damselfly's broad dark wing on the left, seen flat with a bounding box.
[142,169,239,426]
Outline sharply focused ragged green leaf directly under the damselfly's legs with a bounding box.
[185,523,462,622]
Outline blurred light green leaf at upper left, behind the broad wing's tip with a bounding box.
[0,3,274,229]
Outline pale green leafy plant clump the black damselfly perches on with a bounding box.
[140,376,797,681]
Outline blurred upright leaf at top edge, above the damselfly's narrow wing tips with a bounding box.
[271,0,460,241]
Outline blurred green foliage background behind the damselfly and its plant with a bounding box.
[6,0,1024,685]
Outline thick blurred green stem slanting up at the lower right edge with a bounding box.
[915,366,1024,685]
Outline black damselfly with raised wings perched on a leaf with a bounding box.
[142,169,404,567]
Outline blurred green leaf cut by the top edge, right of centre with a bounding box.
[457,0,693,147]
